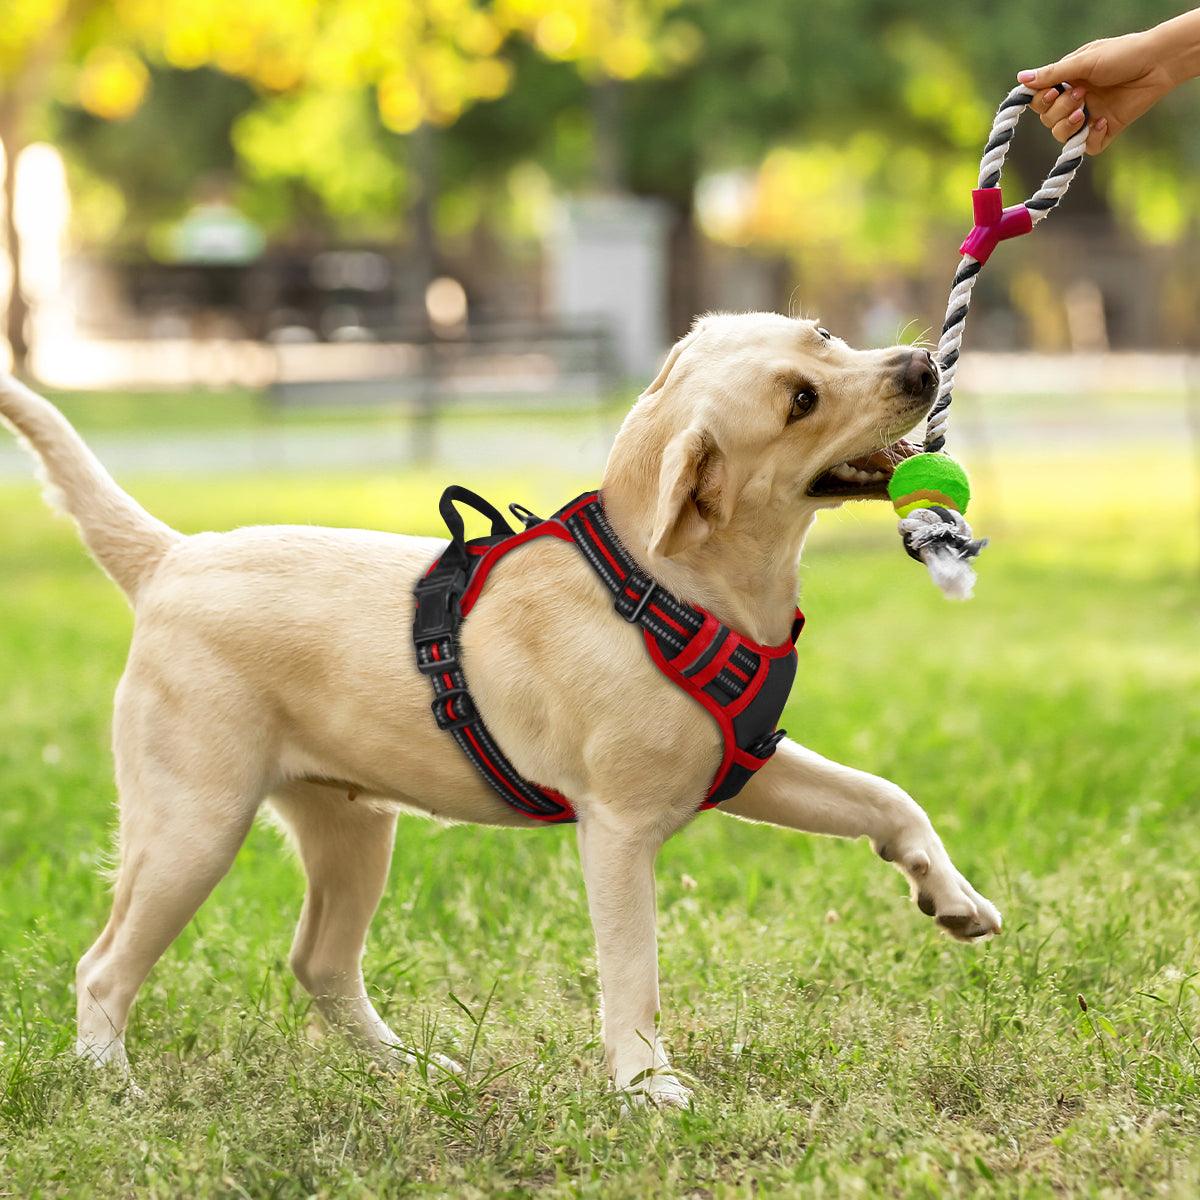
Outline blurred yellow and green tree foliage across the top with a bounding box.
[0,0,1200,274]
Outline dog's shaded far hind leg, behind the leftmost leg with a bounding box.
[270,782,458,1072]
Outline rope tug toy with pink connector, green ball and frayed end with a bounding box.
[902,84,1090,600]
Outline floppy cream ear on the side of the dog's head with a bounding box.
[649,428,732,558]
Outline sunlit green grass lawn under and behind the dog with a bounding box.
[0,427,1200,1198]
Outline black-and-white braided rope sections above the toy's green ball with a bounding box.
[925,84,1090,452]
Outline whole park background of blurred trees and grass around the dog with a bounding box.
[0,0,1200,1196]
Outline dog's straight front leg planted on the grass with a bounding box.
[578,811,691,1108]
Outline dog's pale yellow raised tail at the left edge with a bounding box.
[0,373,182,600]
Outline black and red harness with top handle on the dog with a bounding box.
[413,486,804,824]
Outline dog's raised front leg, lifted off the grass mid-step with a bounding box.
[721,739,1001,941]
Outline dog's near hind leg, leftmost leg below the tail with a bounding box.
[76,676,263,1070]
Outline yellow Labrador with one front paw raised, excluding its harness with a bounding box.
[0,313,1000,1105]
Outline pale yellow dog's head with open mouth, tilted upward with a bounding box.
[606,313,938,559]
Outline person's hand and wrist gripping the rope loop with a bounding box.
[1016,13,1198,154]
